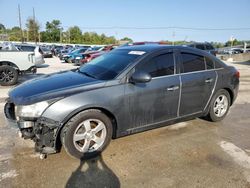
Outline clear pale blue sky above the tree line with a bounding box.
[0,0,250,42]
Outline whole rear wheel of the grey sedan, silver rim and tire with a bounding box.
[208,89,231,122]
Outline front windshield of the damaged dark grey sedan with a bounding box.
[79,50,142,80]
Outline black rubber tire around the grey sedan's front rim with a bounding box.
[61,110,113,159]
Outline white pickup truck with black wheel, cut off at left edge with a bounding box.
[0,43,45,86]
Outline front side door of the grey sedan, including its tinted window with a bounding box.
[125,51,180,129]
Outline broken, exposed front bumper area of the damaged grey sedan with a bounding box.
[4,102,60,154]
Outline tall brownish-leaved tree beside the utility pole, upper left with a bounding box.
[26,18,40,42]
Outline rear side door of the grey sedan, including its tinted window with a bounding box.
[179,50,216,116]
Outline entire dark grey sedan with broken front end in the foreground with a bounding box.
[4,45,239,158]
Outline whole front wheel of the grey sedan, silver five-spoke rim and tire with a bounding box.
[61,110,113,159]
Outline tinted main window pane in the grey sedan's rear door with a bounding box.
[181,52,205,73]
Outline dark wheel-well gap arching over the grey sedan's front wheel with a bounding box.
[56,108,117,149]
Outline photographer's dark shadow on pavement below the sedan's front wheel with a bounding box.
[65,156,120,188]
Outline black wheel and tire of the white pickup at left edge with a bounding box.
[0,65,18,86]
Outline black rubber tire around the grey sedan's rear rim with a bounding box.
[206,89,231,122]
